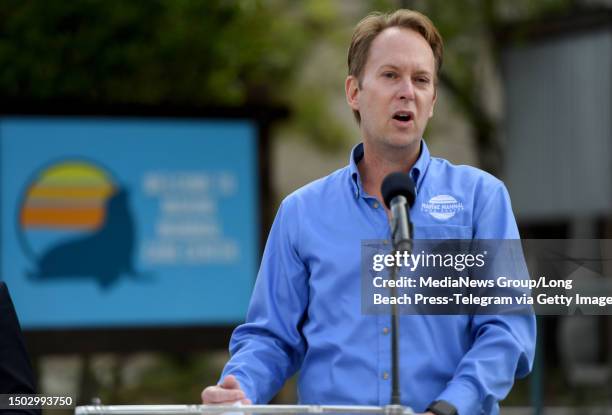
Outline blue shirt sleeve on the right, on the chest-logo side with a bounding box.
[437,181,536,415]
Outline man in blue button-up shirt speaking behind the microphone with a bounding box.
[202,10,535,415]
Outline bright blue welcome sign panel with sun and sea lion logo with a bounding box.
[0,116,260,330]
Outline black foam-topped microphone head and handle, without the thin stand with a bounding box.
[380,172,416,251]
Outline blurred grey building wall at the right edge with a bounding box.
[503,29,612,221]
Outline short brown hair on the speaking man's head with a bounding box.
[348,9,444,122]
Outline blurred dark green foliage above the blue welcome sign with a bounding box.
[0,0,356,150]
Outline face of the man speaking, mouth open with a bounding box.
[346,27,436,149]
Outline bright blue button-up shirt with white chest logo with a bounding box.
[222,141,535,415]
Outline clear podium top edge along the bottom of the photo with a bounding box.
[74,405,414,415]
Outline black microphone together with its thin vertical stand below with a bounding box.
[380,172,416,408]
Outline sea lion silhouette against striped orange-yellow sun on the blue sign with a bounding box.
[19,160,136,288]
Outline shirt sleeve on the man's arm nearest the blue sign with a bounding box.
[221,197,308,404]
